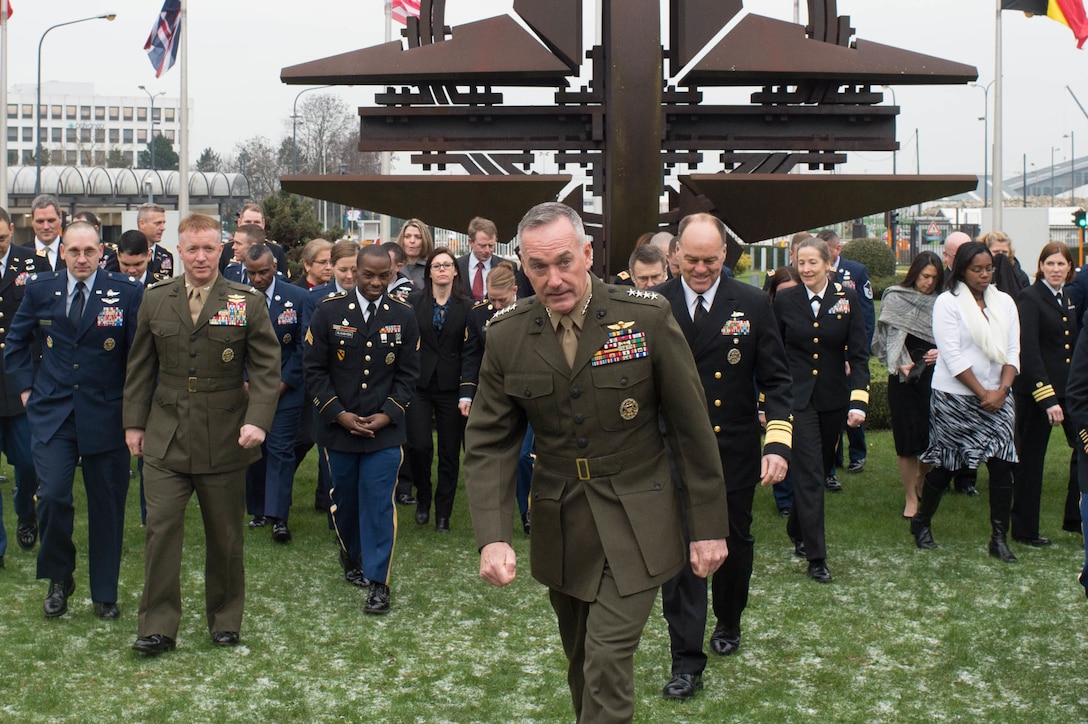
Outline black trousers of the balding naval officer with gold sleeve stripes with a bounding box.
[662,487,755,674]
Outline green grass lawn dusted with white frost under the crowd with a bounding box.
[0,432,1088,723]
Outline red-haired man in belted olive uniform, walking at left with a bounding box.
[124,213,280,655]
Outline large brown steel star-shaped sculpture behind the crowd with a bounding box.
[281,0,978,272]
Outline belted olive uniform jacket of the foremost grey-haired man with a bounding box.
[465,278,728,601]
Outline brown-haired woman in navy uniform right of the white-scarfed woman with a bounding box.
[1012,242,1080,548]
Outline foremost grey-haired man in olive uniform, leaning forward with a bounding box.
[465,204,728,722]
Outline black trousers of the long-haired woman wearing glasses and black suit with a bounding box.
[406,385,465,519]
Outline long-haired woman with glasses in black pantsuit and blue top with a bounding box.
[406,247,472,532]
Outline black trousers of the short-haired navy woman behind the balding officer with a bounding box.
[786,405,846,561]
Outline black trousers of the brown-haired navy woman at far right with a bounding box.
[1012,394,1080,538]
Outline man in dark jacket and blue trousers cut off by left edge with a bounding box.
[0,209,38,568]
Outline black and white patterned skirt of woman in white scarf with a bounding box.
[922,390,1019,470]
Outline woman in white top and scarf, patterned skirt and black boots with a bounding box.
[911,242,1021,563]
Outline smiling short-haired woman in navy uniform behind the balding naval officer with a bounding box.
[775,238,869,584]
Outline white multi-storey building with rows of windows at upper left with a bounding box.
[4,82,193,168]
